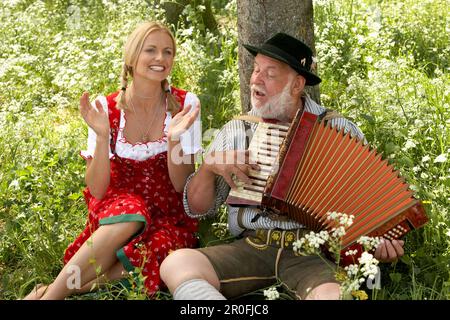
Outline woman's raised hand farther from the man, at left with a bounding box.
[80,92,109,139]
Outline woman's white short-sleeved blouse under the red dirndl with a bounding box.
[81,92,202,161]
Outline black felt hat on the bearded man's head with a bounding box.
[244,33,322,86]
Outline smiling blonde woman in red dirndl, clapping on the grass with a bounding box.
[25,22,201,300]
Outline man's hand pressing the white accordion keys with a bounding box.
[203,150,259,189]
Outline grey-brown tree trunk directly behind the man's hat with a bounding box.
[237,0,320,112]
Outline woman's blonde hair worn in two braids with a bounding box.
[116,21,180,115]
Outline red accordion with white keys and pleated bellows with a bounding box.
[227,112,428,258]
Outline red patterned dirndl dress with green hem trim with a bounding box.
[64,88,198,296]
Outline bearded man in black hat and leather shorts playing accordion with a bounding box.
[160,33,403,299]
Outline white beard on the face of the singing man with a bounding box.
[250,83,295,122]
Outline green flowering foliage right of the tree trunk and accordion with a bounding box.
[314,0,450,299]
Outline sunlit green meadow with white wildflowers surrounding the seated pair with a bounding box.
[0,0,450,300]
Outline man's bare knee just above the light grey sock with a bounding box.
[160,249,218,292]
